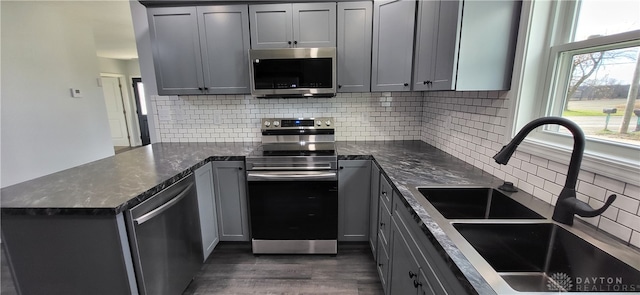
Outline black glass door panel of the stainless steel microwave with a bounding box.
[253,58,333,89]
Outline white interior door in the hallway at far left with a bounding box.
[101,77,131,146]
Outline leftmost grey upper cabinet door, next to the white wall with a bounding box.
[147,7,204,95]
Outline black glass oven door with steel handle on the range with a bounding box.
[247,171,338,240]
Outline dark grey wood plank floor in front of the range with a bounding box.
[184,243,383,295]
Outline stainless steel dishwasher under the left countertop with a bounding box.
[126,174,202,295]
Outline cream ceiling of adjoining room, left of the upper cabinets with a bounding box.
[43,0,138,59]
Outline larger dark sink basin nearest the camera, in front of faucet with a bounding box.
[453,223,640,292]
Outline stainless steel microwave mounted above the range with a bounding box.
[249,47,336,98]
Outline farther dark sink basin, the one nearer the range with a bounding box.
[418,187,544,219]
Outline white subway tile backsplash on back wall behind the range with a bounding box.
[151,92,423,142]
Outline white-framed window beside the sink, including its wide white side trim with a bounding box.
[513,0,640,183]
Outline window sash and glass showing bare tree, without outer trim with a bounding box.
[546,0,640,147]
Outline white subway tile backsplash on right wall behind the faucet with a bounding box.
[421,91,640,247]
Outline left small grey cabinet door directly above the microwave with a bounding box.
[249,4,293,49]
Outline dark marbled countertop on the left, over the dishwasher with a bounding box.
[0,143,259,215]
